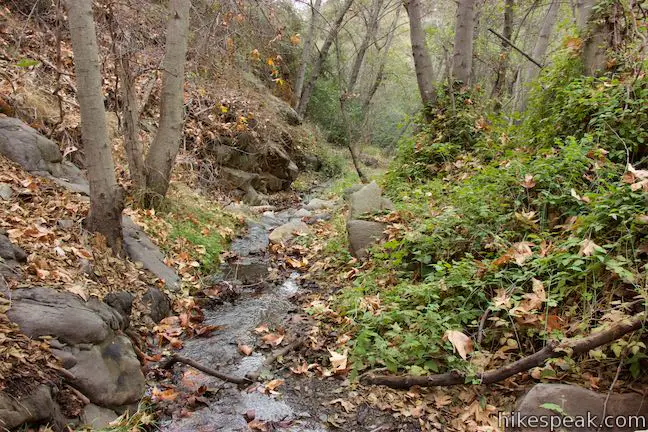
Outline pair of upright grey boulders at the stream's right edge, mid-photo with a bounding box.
[345,182,394,260]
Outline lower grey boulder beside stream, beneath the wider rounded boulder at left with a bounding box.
[67,335,146,407]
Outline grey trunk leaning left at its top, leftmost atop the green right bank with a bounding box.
[405,0,436,116]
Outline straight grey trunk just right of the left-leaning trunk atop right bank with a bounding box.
[452,0,475,84]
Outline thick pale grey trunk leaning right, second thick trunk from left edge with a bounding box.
[144,0,191,207]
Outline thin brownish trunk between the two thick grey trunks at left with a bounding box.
[117,55,146,191]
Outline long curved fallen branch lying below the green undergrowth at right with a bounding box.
[361,312,646,389]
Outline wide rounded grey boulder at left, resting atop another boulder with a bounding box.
[7,287,125,345]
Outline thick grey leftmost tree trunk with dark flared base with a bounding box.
[66,0,124,255]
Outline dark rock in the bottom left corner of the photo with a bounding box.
[0,385,65,430]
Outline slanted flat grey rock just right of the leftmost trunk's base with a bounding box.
[122,215,180,291]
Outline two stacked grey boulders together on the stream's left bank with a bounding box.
[7,288,145,408]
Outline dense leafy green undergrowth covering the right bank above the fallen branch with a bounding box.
[336,54,648,374]
